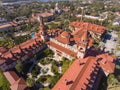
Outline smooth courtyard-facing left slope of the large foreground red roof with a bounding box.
[52,59,84,90]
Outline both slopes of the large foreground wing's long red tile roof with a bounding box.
[52,57,98,90]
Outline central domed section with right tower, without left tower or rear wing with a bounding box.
[48,27,94,59]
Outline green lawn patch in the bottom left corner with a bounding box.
[0,71,10,90]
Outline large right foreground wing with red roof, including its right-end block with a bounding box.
[52,54,115,90]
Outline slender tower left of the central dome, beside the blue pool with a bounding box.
[38,17,47,41]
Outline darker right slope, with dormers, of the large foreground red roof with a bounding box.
[70,57,99,90]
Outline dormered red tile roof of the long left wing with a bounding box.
[1,38,41,65]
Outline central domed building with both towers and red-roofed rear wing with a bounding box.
[39,19,105,59]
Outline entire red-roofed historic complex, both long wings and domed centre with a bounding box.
[0,17,115,90]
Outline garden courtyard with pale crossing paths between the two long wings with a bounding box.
[27,48,73,90]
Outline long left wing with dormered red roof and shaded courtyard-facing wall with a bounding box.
[0,38,46,71]
